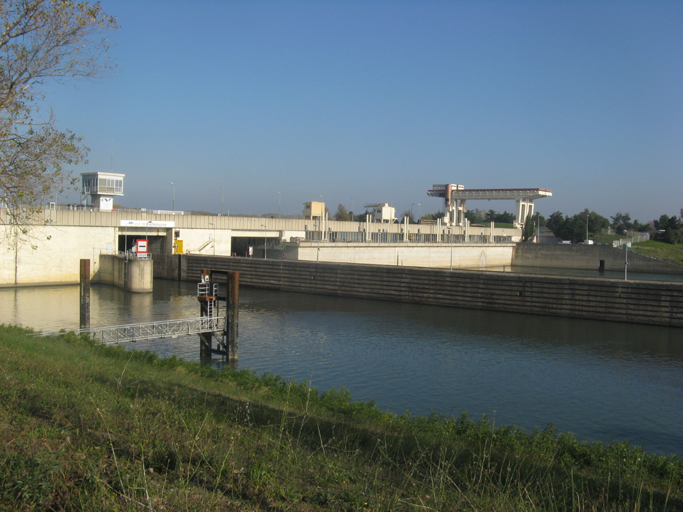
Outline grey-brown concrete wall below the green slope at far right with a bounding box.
[512,243,683,274]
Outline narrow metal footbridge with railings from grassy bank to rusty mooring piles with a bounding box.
[37,316,225,345]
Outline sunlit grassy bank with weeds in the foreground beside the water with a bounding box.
[0,326,683,511]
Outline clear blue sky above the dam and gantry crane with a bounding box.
[49,0,683,222]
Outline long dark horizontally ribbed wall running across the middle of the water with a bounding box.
[162,255,683,327]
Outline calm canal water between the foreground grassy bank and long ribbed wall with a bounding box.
[0,280,683,456]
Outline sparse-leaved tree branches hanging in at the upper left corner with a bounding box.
[0,0,117,248]
